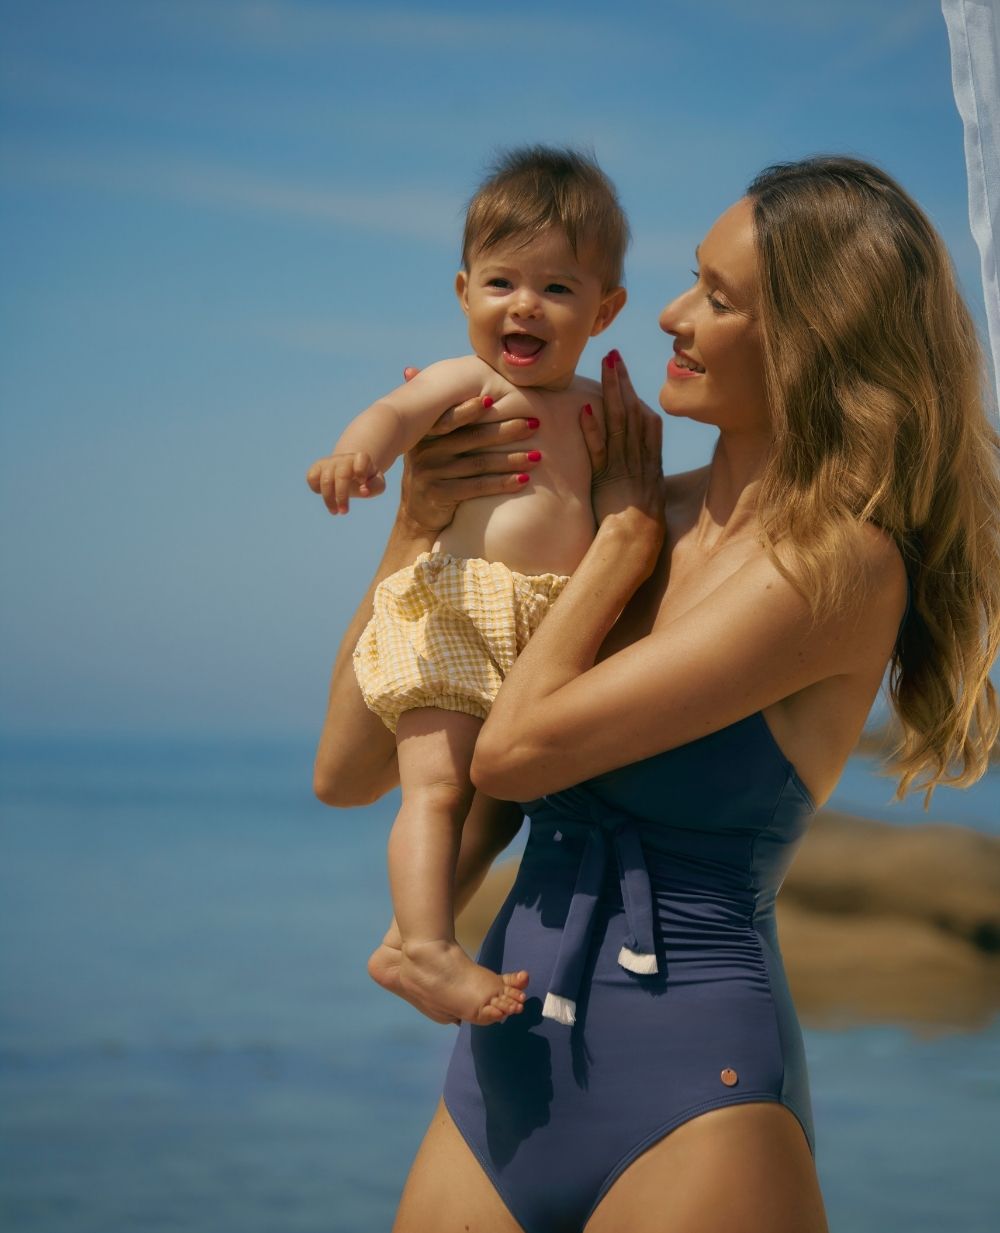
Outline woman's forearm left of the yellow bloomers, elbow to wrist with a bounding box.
[313,512,434,808]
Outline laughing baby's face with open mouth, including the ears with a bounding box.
[455,228,625,390]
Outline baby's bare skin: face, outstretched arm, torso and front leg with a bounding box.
[313,228,625,1026]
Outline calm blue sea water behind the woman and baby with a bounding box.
[0,743,1000,1233]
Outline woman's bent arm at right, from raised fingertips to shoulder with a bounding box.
[472,355,898,800]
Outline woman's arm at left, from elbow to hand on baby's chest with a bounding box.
[313,399,547,808]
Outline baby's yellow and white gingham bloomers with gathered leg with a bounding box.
[354,552,570,732]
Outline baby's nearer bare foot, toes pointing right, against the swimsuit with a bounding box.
[400,941,528,1027]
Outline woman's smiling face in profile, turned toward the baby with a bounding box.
[660,197,769,433]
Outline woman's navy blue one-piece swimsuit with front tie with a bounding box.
[444,714,814,1233]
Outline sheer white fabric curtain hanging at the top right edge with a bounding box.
[941,0,1000,406]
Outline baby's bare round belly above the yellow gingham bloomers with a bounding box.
[435,487,596,575]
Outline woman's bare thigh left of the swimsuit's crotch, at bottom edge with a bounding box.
[392,1101,520,1233]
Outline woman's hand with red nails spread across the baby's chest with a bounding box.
[400,369,538,534]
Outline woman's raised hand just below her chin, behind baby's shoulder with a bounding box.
[581,351,665,541]
